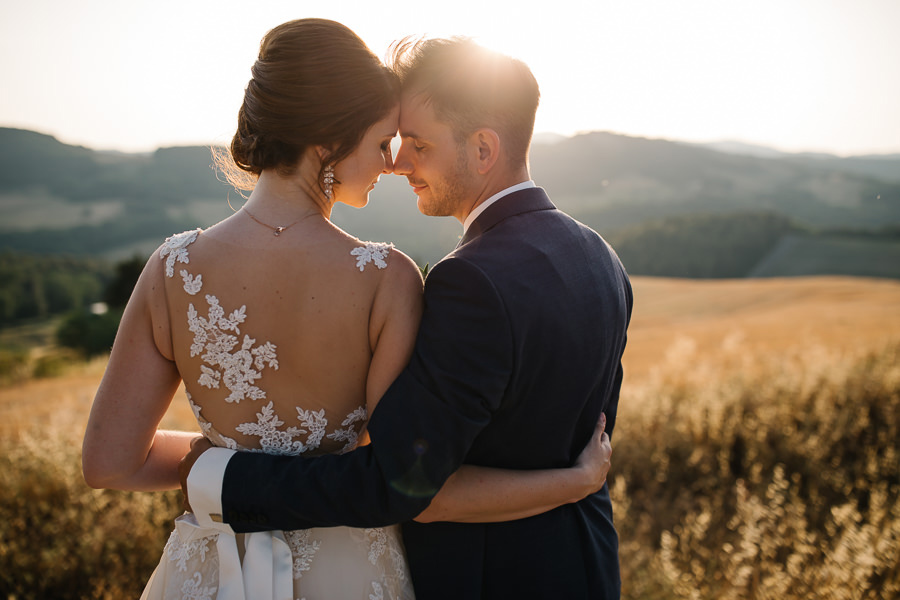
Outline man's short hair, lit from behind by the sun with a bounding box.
[389,37,540,165]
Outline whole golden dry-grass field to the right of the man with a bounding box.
[612,278,900,600]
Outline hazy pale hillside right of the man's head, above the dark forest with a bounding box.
[531,132,900,230]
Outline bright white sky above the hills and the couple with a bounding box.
[0,0,900,155]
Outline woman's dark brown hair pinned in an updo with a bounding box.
[217,19,399,190]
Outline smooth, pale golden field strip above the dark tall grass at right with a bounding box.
[625,277,900,382]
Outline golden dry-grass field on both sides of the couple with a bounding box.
[0,277,900,600]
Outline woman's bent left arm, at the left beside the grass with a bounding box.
[82,253,197,491]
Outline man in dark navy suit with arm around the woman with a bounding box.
[186,39,632,600]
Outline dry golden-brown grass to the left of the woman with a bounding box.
[0,359,193,600]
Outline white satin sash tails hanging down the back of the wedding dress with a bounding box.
[141,513,294,600]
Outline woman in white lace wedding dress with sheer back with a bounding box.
[83,19,611,600]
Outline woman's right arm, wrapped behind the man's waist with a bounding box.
[366,251,612,523]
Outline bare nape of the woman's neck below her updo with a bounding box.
[244,169,334,220]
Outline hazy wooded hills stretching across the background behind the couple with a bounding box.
[0,128,900,277]
